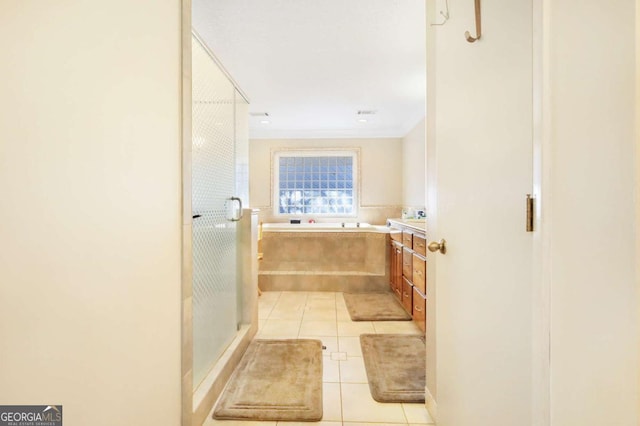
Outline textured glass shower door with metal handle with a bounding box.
[192,37,238,388]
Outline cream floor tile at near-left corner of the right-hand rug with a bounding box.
[340,383,407,424]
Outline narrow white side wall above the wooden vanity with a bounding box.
[402,118,427,208]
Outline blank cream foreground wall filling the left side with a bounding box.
[0,0,181,426]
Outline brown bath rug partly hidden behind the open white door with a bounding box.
[360,334,427,402]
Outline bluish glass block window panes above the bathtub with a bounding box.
[274,151,357,216]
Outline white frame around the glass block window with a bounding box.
[271,149,360,218]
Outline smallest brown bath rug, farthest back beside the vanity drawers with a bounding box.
[344,293,411,321]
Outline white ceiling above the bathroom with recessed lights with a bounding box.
[193,0,426,138]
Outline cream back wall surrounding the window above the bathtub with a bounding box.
[249,138,402,224]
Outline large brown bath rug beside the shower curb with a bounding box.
[213,339,322,421]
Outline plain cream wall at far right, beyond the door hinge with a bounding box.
[542,0,639,425]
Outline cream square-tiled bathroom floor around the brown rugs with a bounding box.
[203,291,434,426]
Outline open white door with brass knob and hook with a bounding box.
[427,0,532,426]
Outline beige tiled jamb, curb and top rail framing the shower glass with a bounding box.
[180,6,258,426]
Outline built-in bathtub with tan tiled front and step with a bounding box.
[258,222,389,292]
